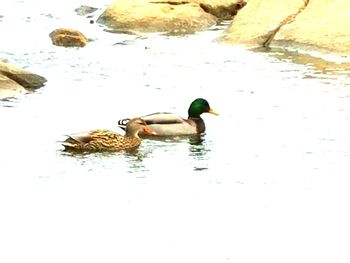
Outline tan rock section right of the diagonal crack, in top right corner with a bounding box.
[271,0,350,58]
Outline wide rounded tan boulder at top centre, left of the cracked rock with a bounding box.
[97,0,217,34]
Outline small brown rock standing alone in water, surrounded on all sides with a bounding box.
[50,28,88,47]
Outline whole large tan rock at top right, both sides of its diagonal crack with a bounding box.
[220,0,350,61]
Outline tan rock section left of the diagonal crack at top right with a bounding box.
[220,0,306,47]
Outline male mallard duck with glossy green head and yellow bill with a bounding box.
[118,98,218,136]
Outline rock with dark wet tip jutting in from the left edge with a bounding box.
[0,61,46,98]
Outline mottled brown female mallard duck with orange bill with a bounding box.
[62,118,155,152]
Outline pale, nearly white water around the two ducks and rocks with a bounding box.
[0,0,350,263]
